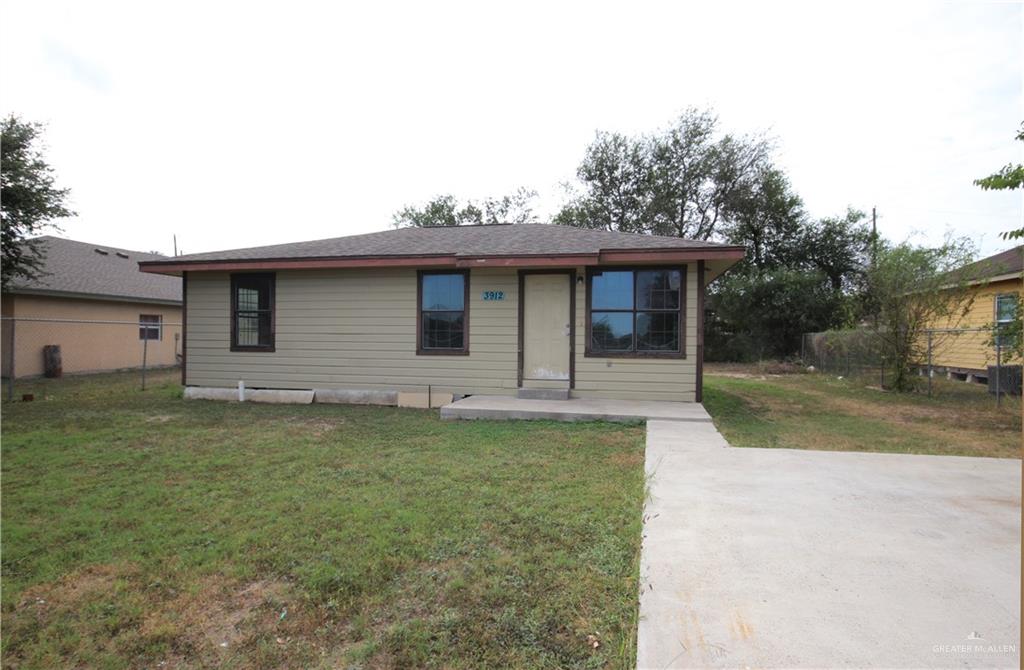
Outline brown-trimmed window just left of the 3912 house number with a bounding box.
[416,270,469,354]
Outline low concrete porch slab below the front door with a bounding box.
[441,395,711,423]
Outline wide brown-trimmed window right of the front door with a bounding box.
[586,266,686,358]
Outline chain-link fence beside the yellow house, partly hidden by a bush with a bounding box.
[800,328,1021,404]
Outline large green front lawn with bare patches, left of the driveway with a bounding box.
[2,372,644,668]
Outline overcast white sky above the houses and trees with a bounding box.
[0,0,1024,260]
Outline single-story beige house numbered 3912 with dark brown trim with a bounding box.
[139,224,743,407]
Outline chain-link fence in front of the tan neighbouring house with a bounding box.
[0,315,182,401]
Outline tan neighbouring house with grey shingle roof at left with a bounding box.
[0,236,181,377]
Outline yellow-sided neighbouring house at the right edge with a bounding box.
[932,246,1024,381]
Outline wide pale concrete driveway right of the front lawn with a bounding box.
[637,421,1021,669]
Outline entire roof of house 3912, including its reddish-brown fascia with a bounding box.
[141,223,743,273]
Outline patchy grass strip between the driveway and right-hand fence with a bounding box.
[705,366,1021,458]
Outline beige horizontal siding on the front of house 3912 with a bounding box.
[186,265,696,402]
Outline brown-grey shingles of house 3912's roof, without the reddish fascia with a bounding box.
[161,223,727,262]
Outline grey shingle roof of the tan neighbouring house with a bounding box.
[10,236,181,304]
